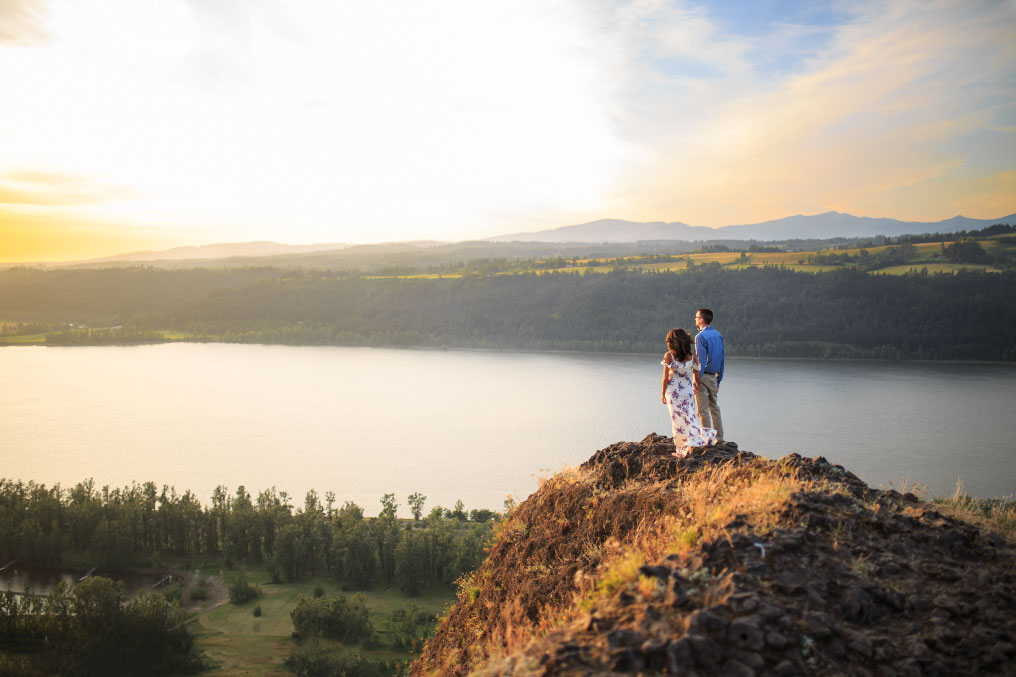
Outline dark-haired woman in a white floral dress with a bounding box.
[659,329,716,458]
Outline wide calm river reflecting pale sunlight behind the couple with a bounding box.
[0,344,1016,512]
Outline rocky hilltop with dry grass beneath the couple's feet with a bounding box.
[411,435,1016,676]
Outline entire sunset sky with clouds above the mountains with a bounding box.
[0,0,1016,262]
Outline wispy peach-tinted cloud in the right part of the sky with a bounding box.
[601,2,1016,226]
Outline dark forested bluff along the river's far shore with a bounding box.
[0,262,1016,361]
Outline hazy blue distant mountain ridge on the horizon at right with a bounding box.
[485,211,1016,242]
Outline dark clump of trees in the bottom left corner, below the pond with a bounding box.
[0,576,204,677]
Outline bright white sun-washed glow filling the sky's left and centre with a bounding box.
[0,0,621,240]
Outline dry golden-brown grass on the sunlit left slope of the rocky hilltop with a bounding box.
[414,458,829,674]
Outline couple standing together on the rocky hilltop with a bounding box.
[659,308,723,457]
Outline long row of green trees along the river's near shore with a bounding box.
[0,480,491,595]
